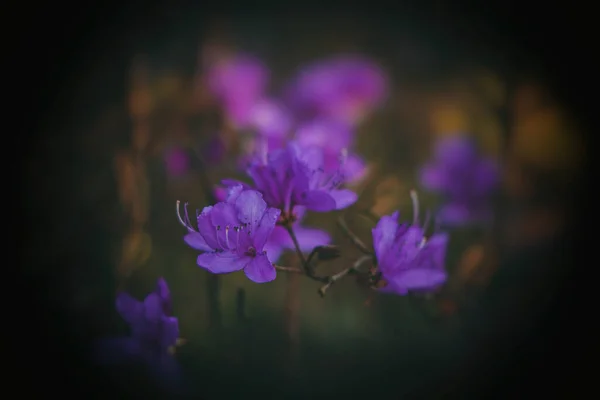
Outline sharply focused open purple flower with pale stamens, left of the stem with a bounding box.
[178,186,280,283]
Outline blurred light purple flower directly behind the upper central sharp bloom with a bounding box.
[295,119,367,183]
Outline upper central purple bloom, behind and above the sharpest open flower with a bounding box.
[223,142,357,218]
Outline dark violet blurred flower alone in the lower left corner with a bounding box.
[95,278,179,383]
